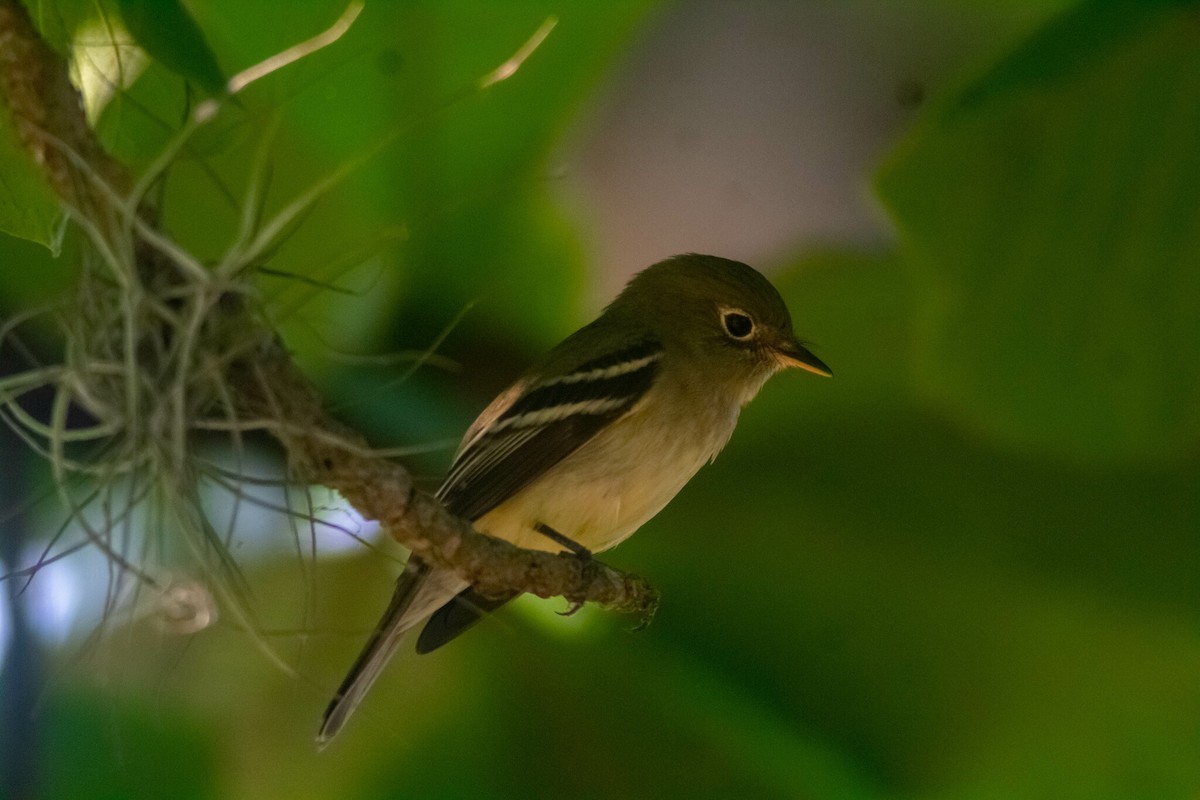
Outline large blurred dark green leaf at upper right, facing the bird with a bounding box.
[878,2,1200,461]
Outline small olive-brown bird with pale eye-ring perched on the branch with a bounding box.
[317,253,832,746]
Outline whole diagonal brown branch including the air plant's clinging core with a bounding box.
[0,0,658,618]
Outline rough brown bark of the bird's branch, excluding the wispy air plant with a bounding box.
[0,0,658,619]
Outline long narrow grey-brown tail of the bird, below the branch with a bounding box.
[317,555,451,747]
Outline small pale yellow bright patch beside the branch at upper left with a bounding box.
[71,17,150,125]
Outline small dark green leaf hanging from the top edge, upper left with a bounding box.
[116,0,226,95]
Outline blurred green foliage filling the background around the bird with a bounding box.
[0,0,1200,798]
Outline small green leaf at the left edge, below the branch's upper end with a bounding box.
[0,103,62,251]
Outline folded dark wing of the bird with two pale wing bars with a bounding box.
[438,338,664,521]
